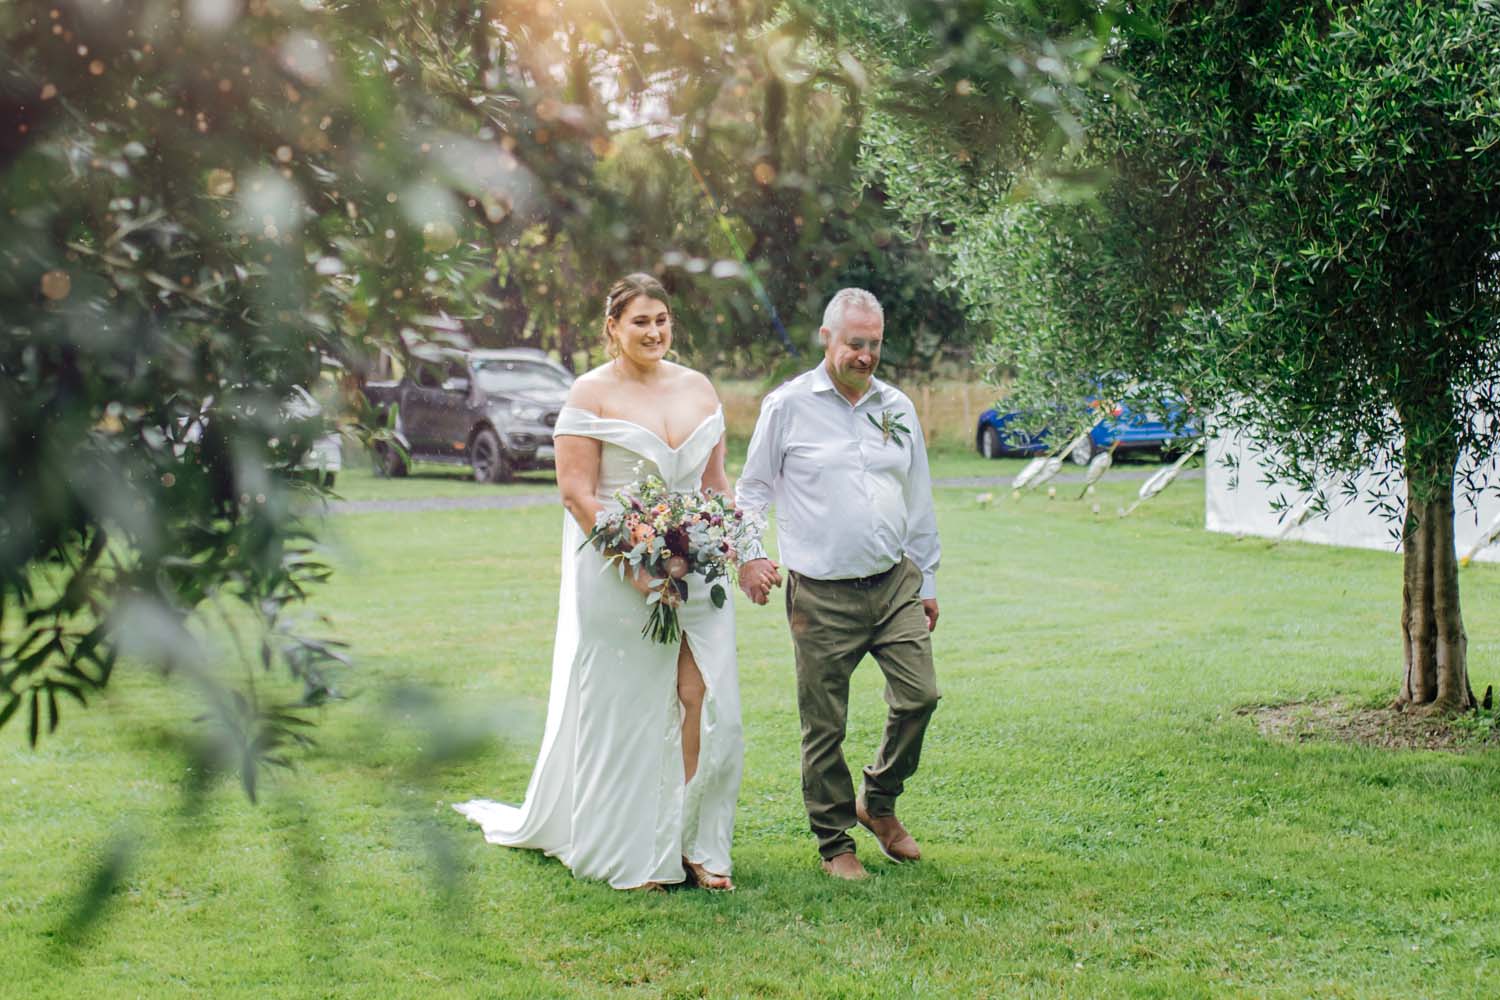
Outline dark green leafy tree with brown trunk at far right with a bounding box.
[1197,0,1500,711]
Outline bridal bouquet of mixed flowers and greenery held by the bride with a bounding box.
[584,475,749,645]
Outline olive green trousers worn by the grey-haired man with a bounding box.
[786,558,939,859]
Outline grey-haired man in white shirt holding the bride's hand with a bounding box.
[737,288,939,879]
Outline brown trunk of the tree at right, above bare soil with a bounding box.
[1395,460,1475,715]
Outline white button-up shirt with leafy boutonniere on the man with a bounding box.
[735,364,941,598]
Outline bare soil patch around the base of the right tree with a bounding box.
[1236,699,1500,753]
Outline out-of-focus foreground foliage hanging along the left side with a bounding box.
[0,0,552,798]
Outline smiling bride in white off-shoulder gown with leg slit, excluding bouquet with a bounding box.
[453,274,744,889]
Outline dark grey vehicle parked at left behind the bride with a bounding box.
[365,348,573,483]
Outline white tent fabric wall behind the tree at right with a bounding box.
[1205,435,1500,562]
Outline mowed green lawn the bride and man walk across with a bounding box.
[0,456,1500,997]
